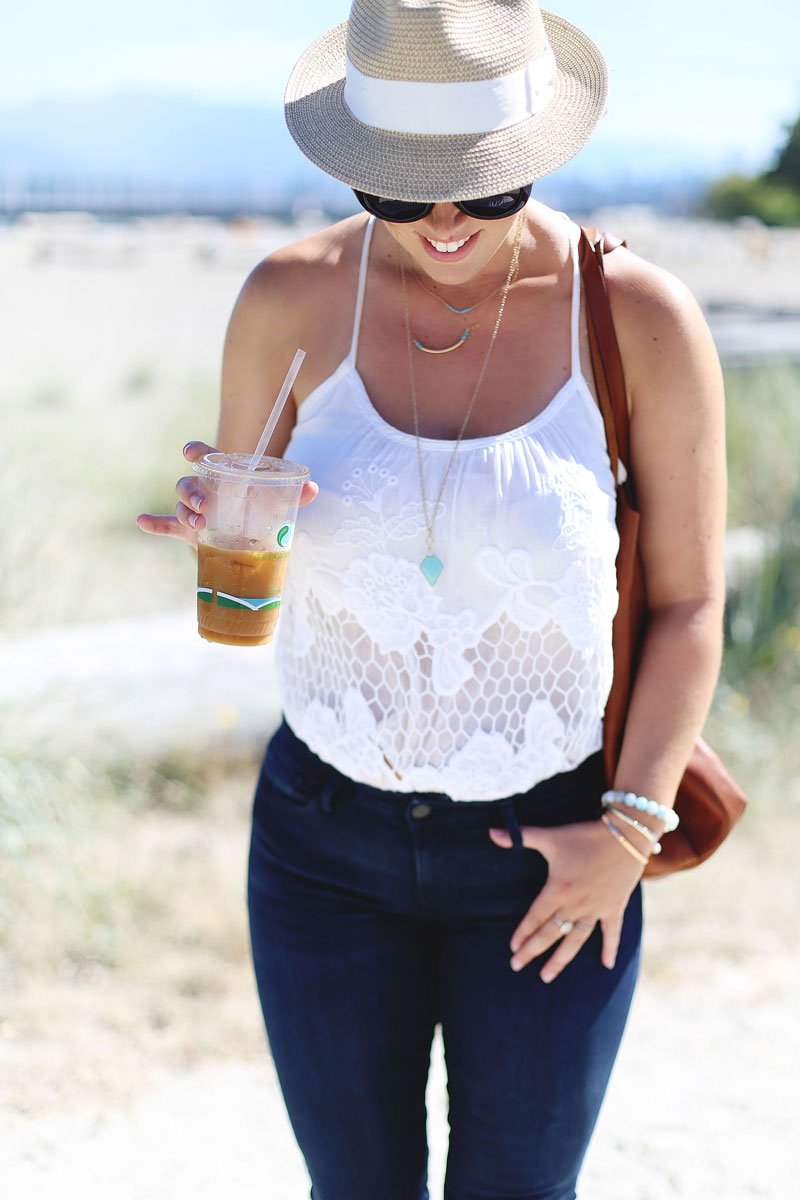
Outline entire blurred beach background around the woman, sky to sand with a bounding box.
[0,0,800,1200]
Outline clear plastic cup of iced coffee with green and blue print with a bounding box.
[192,451,308,646]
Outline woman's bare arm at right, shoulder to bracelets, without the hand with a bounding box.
[608,250,727,805]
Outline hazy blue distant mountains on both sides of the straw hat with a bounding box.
[0,91,719,218]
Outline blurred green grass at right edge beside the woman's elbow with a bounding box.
[709,364,800,796]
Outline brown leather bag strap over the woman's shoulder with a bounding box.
[579,228,633,499]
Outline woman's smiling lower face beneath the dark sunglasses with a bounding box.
[381,204,524,284]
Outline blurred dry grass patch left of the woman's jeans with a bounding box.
[0,760,264,1111]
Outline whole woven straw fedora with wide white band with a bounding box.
[285,0,608,200]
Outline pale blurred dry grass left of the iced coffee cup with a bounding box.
[0,369,216,630]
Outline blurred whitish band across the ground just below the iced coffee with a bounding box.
[0,607,279,761]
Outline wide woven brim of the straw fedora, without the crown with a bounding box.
[284,10,608,202]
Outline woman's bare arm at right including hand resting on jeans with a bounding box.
[492,258,726,982]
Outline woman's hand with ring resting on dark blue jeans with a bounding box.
[489,821,644,983]
